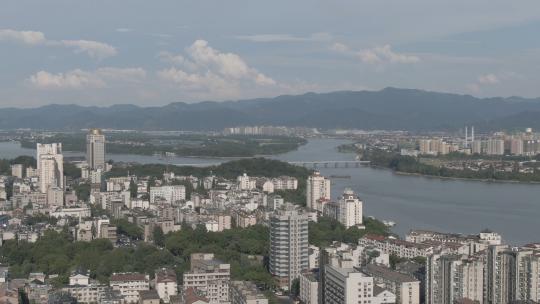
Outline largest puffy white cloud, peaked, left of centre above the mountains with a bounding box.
[157,40,277,97]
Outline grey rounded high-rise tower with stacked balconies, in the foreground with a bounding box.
[269,205,309,288]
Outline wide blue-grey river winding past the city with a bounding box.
[0,139,540,245]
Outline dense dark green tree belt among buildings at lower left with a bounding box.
[0,226,274,288]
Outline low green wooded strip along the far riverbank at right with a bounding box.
[363,150,540,182]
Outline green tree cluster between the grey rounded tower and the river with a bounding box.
[309,216,390,247]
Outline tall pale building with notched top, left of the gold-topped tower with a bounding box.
[37,143,64,193]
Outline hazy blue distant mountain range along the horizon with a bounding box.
[0,88,540,131]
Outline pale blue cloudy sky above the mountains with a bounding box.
[0,0,540,108]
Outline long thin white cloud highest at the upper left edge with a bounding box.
[0,29,118,59]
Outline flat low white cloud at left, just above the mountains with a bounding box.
[28,67,146,90]
